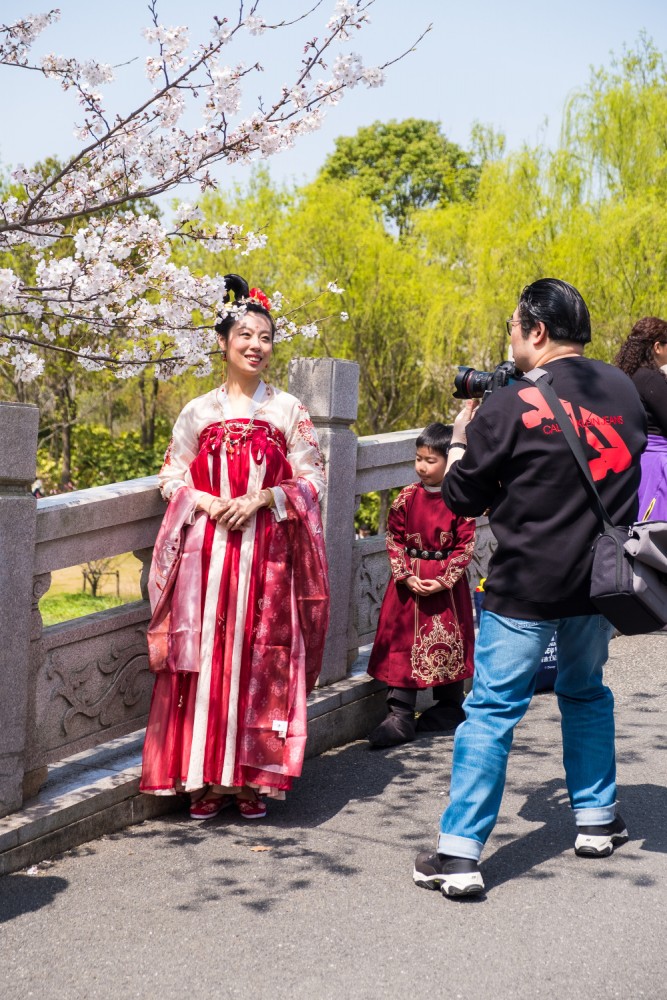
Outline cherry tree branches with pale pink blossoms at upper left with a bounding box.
[0,0,428,381]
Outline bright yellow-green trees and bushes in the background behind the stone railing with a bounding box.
[11,36,667,484]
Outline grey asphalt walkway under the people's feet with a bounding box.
[0,633,667,1000]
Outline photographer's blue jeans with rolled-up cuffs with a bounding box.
[438,611,616,861]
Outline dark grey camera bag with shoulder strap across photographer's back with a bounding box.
[524,368,667,635]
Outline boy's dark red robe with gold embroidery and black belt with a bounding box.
[368,483,475,688]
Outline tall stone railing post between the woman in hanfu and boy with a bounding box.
[289,358,359,684]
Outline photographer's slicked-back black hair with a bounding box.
[519,278,591,344]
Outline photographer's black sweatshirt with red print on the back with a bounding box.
[442,357,646,621]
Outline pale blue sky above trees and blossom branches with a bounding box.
[0,0,667,195]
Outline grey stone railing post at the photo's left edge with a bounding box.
[0,403,39,816]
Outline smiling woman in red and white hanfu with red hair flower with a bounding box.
[141,275,329,819]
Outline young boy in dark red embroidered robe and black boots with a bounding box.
[368,423,475,747]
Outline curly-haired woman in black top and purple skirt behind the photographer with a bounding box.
[615,316,667,521]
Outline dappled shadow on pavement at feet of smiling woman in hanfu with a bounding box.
[94,743,412,914]
